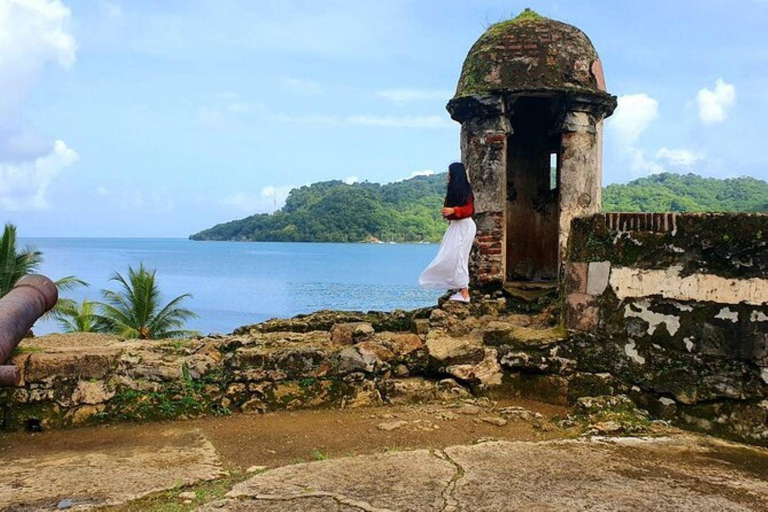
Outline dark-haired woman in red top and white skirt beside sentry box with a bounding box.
[419,162,477,302]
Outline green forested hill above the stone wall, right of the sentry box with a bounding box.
[603,173,768,212]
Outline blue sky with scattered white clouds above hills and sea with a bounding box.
[0,0,768,237]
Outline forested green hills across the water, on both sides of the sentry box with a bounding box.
[190,173,768,242]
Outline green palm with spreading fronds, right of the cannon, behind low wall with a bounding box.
[98,263,199,340]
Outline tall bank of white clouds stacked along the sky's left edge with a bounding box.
[0,0,78,210]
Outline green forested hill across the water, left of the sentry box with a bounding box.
[190,174,445,242]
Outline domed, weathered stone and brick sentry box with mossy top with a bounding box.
[447,10,616,288]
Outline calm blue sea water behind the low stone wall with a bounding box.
[21,238,439,334]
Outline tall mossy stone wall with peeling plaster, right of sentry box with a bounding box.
[560,213,768,443]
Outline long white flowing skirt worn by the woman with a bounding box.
[419,217,477,290]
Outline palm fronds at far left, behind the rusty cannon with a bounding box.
[0,224,88,307]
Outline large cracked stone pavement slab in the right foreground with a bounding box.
[197,436,768,512]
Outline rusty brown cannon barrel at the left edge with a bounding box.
[0,274,59,386]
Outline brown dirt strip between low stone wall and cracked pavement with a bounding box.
[0,400,567,469]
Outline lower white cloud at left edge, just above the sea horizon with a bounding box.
[0,140,78,211]
